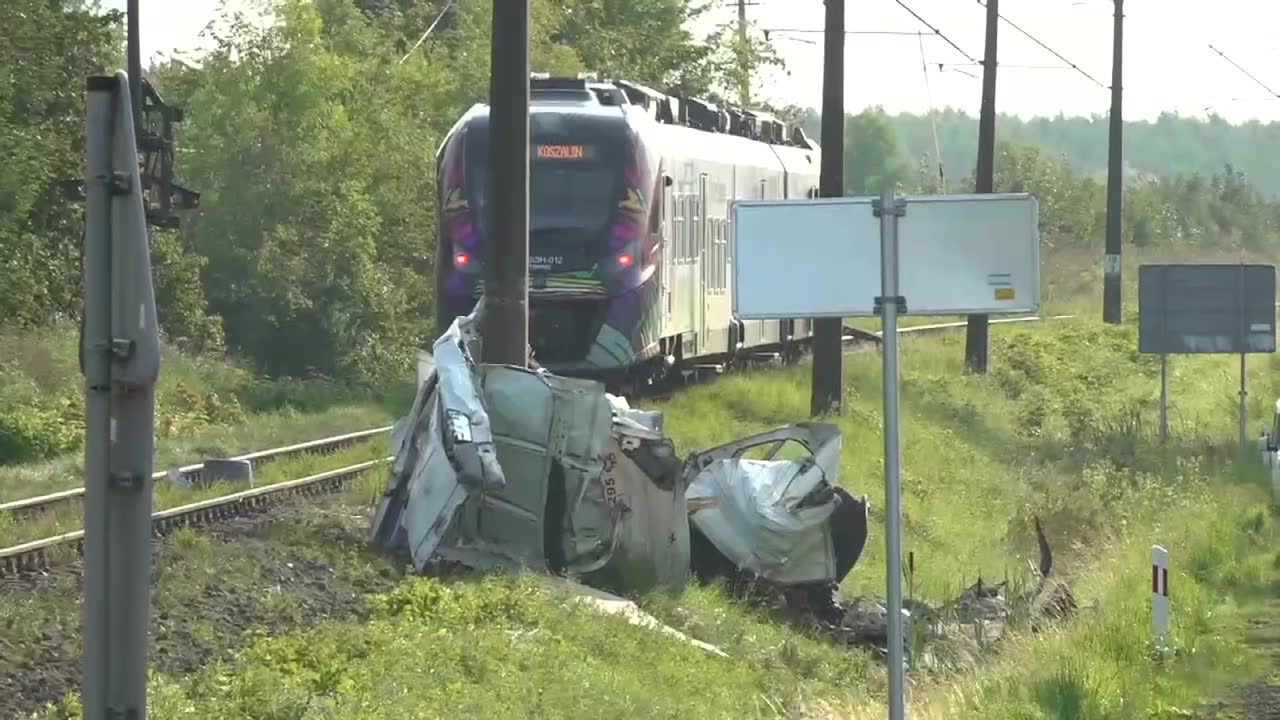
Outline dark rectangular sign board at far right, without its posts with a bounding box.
[1138,264,1276,355]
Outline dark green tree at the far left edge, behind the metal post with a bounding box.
[0,0,122,327]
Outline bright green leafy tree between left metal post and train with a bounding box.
[159,0,447,382]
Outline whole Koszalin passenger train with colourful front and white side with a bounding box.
[436,76,820,391]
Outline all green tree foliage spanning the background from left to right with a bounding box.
[0,0,1280,383]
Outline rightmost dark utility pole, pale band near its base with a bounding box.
[1102,0,1124,325]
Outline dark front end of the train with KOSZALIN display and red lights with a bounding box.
[436,104,660,382]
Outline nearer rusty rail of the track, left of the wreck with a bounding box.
[0,457,393,577]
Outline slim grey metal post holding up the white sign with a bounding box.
[878,186,906,720]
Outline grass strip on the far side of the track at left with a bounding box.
[0,327,411,502]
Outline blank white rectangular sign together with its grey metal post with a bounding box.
[731,188,1041,720]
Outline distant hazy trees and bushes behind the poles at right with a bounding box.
[804,108,1280,255]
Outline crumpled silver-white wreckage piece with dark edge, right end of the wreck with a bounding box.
[685,423,867,584]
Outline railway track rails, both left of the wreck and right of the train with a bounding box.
[0,310,1074,577]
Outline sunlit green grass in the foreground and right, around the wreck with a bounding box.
[20,312,1277,719]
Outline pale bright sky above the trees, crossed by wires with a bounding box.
[102,0,1280,123]
